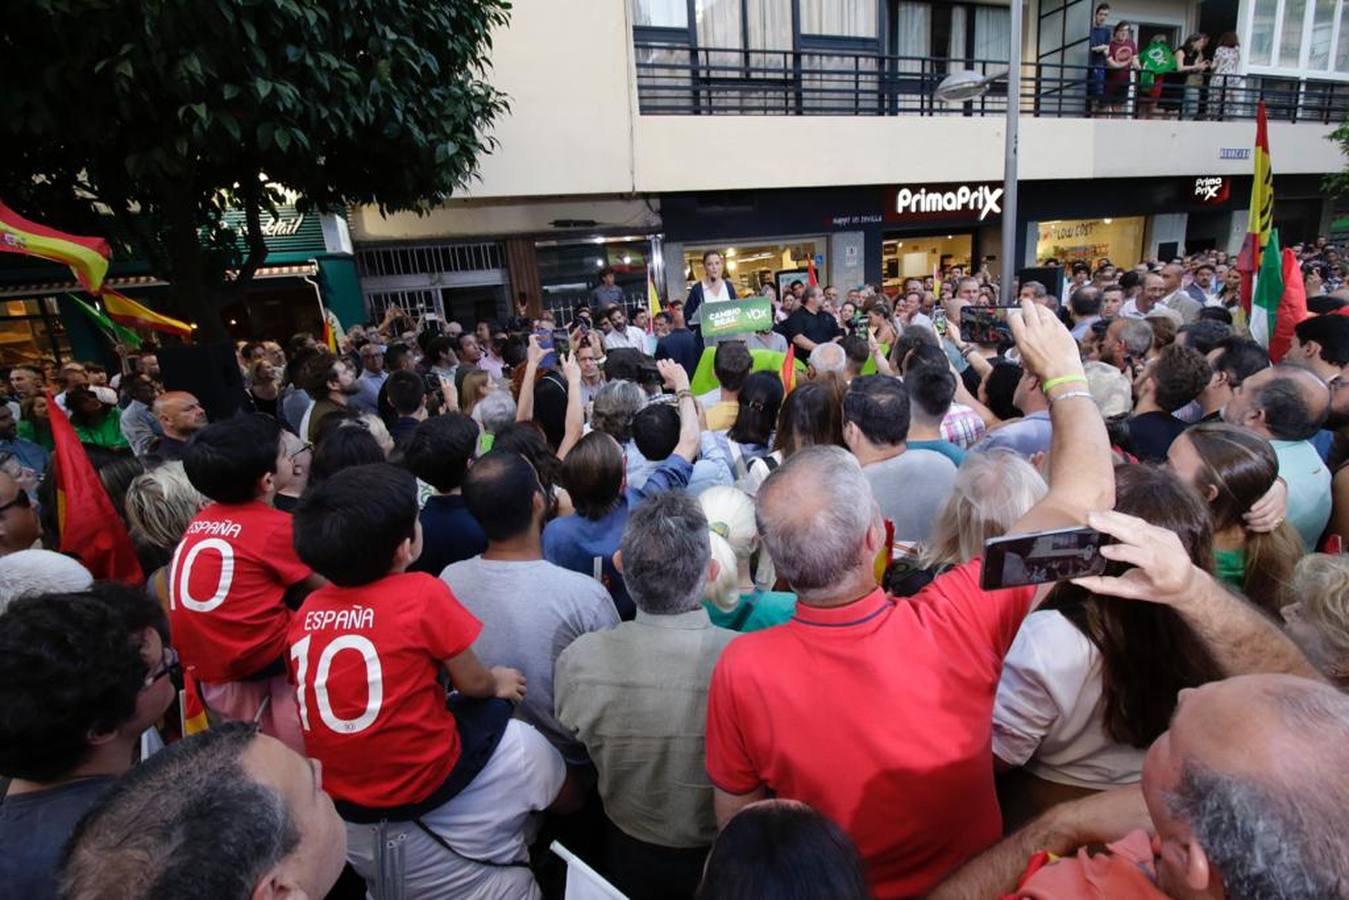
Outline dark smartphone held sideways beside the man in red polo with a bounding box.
[979,528,1110,591]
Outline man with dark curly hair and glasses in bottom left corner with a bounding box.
[0,585,178,900]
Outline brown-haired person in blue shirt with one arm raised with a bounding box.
[544,359,700,619]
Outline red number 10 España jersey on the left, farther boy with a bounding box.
[169,501,310,683]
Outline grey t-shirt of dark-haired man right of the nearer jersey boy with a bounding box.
[440,556,618,764]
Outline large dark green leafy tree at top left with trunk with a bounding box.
[0,0,510,337]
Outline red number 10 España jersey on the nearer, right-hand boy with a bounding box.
[286,572,483,807]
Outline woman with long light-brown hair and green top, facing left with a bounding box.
[1167,422,1303,618]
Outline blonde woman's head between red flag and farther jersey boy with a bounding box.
[125,461,210,606]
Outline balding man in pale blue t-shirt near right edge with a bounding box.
[1222,364,1330,549]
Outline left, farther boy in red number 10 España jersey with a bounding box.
[169,416,322,753]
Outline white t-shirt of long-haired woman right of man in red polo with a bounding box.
[993,610,1147,789]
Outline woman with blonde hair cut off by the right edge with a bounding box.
[1279,553,1349,691]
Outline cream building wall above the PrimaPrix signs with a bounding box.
[353,0,1344,211]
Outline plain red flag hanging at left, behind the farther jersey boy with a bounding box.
[47,390,146,584]
